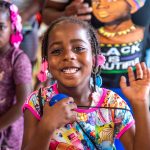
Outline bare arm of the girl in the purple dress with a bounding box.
[0,83,31,130]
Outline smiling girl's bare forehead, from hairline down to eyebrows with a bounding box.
[48,22,91,46]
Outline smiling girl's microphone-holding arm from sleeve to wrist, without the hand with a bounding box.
[22,110,55,150]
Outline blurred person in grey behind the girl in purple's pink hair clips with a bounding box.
[10,0,44,67]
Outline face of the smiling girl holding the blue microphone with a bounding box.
[48,21,92,87]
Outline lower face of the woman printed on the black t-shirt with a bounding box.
[92,0,130,23]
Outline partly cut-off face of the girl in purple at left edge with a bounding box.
[0,11,11,51]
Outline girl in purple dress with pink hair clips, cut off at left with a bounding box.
[0,1,32,150]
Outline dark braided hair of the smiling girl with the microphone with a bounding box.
[42,17,101,90]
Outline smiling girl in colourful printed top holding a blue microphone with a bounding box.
[22,18,150,150]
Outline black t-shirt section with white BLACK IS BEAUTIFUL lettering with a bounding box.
[101,40,145,88]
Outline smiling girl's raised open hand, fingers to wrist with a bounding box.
[120,63,150,105]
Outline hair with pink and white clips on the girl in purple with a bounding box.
[0,0,23,48]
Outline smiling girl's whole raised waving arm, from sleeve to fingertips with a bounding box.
[120,63,150,150]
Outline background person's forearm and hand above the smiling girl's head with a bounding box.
[42,0,92,24]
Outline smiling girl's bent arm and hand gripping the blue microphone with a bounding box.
[22,97,77,150]
